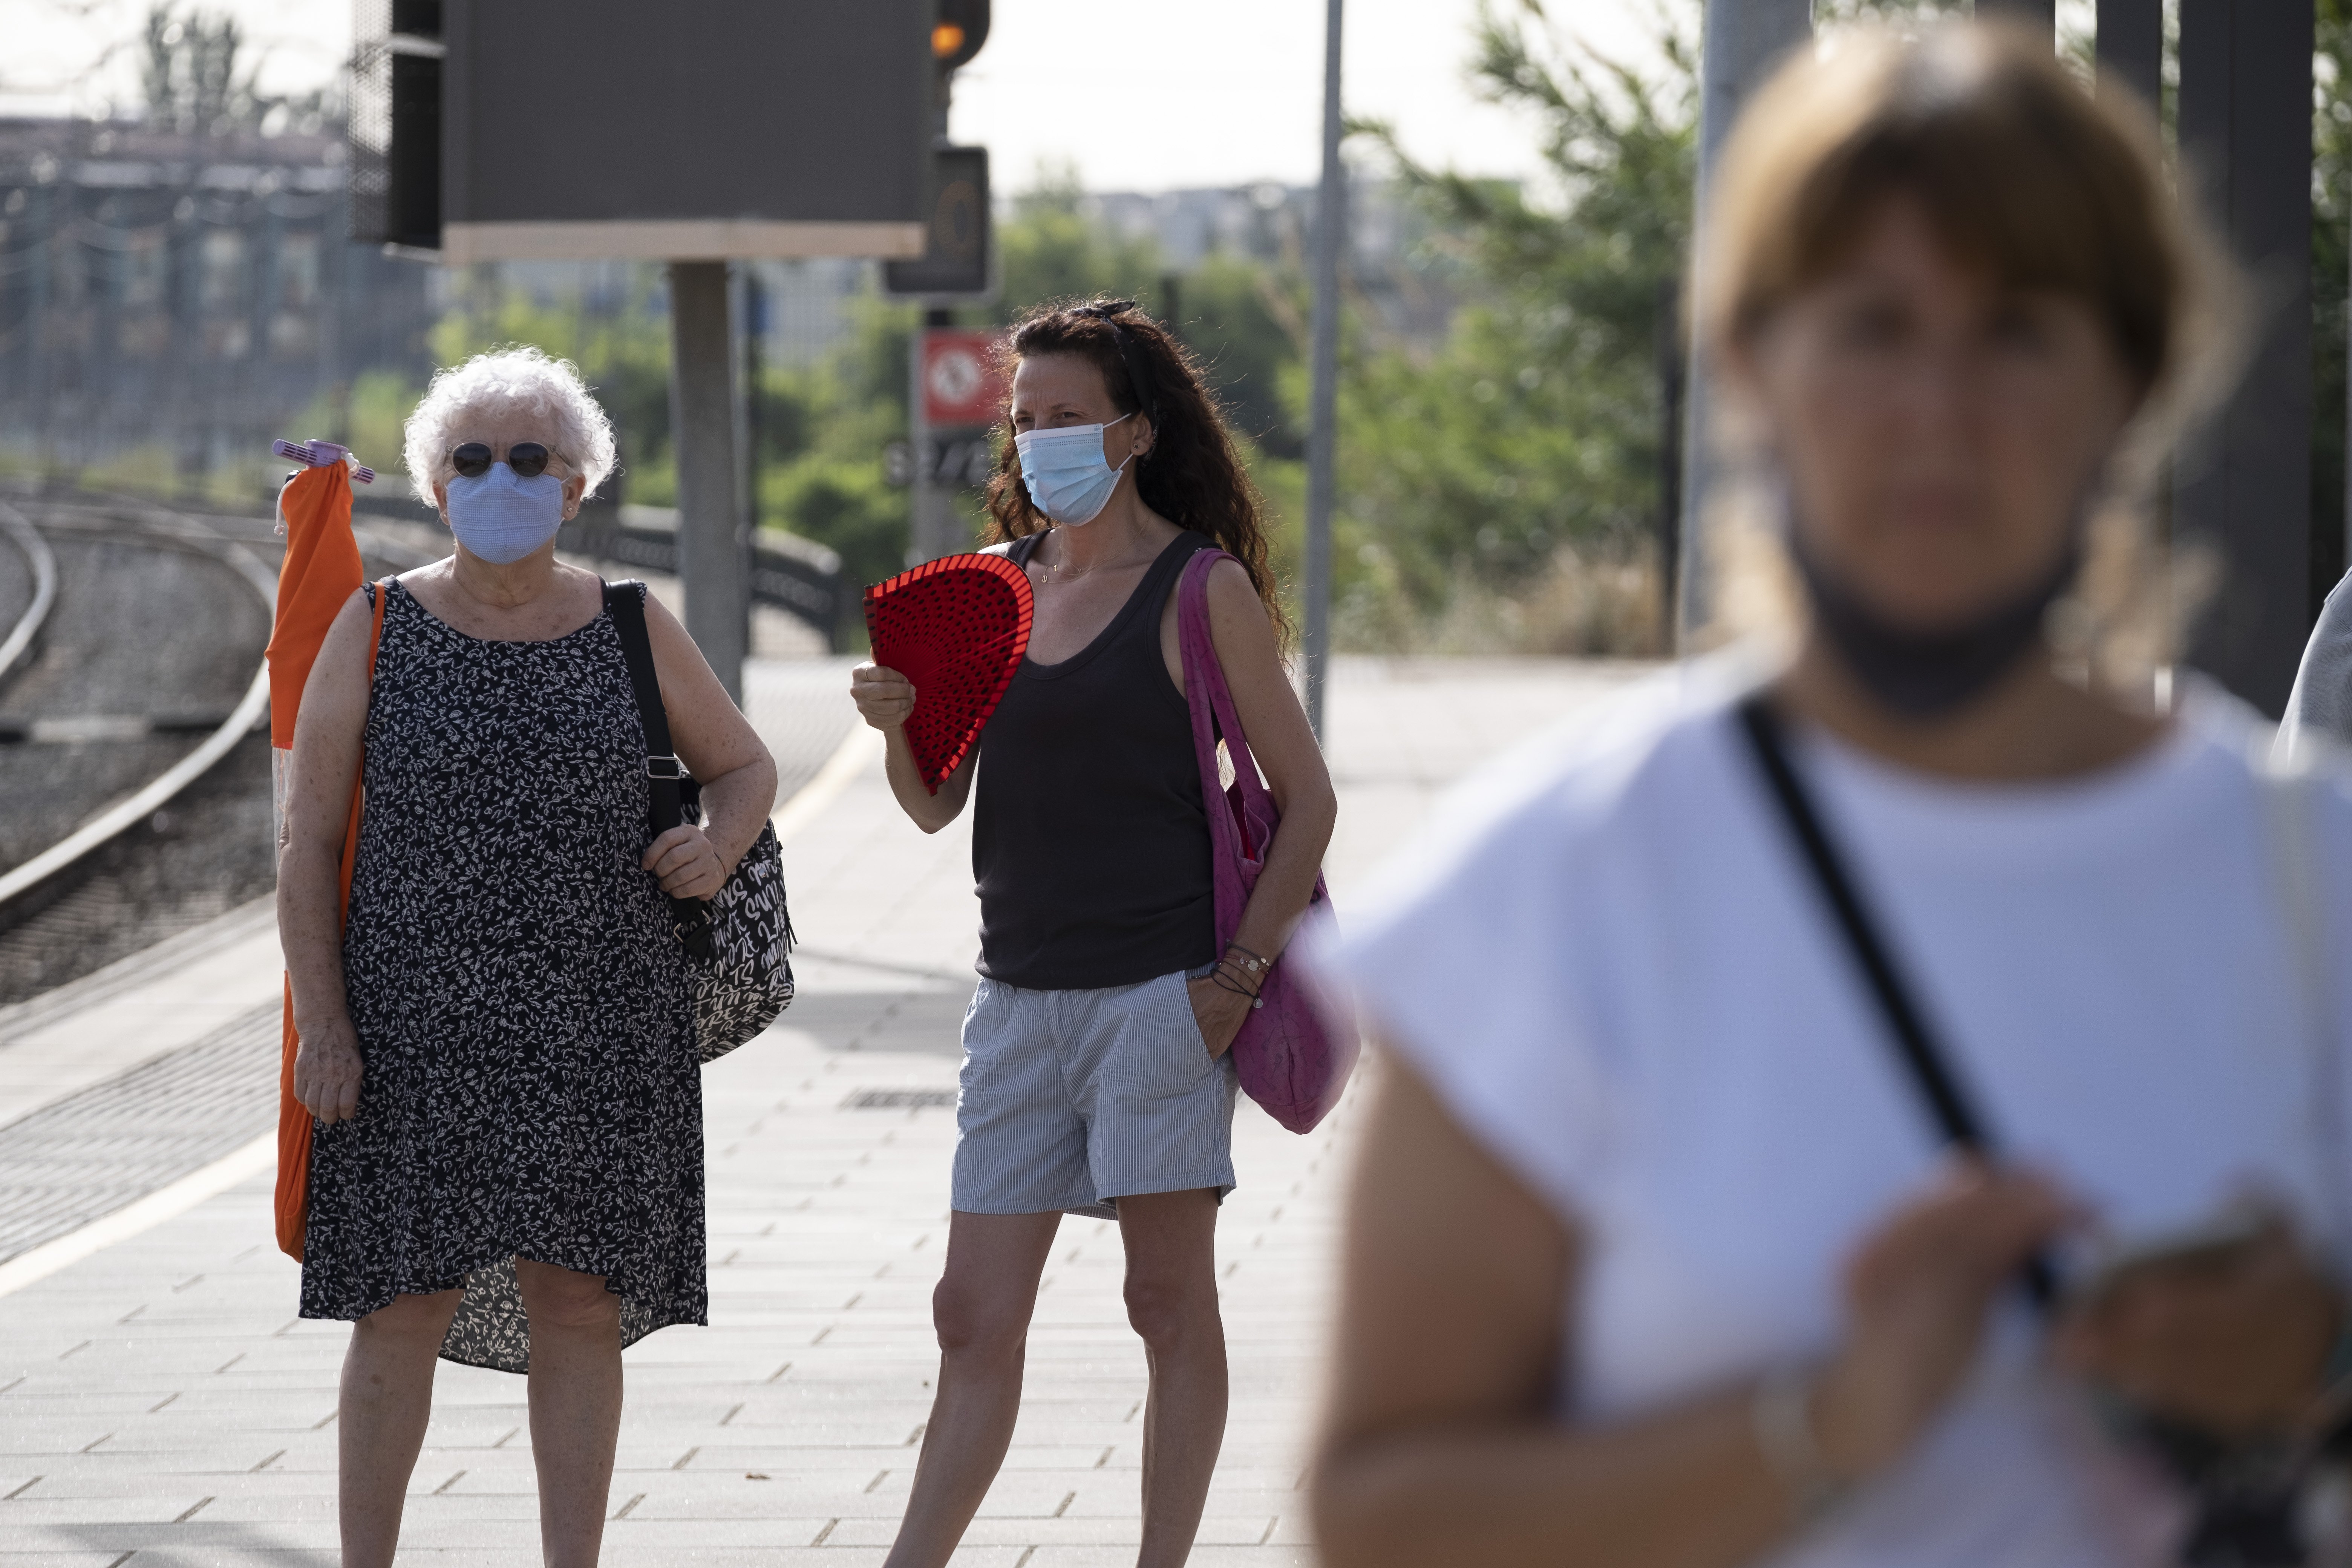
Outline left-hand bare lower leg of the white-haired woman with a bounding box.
[334,1291,466,1568]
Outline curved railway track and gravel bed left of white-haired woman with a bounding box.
[0,492,428,1004]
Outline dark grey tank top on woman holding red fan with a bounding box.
[971,531,1216,990]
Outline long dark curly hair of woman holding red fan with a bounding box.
[988,296,1289,637]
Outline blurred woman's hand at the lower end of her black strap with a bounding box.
[1811,1161,2075,1481]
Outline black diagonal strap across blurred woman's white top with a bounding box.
[1738,691,2058,1312]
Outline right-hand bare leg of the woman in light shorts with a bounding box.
[1119,1187,1225,1568]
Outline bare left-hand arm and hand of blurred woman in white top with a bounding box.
[1312,1053,2058,1568]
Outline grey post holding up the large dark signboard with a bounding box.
[670,261,750,705]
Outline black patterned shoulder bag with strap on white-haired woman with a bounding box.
[605,583,793,1063]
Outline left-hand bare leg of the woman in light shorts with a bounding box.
[884,1213,1061,1568]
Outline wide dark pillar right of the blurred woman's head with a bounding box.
[2173,0,2324,715]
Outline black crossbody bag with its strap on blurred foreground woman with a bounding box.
[1738,691,2347,1568]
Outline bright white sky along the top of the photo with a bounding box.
[0,0,1651,190]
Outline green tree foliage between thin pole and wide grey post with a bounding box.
[1338,0,1696,637]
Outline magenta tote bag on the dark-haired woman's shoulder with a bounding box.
[1176,550,1360,1133]
